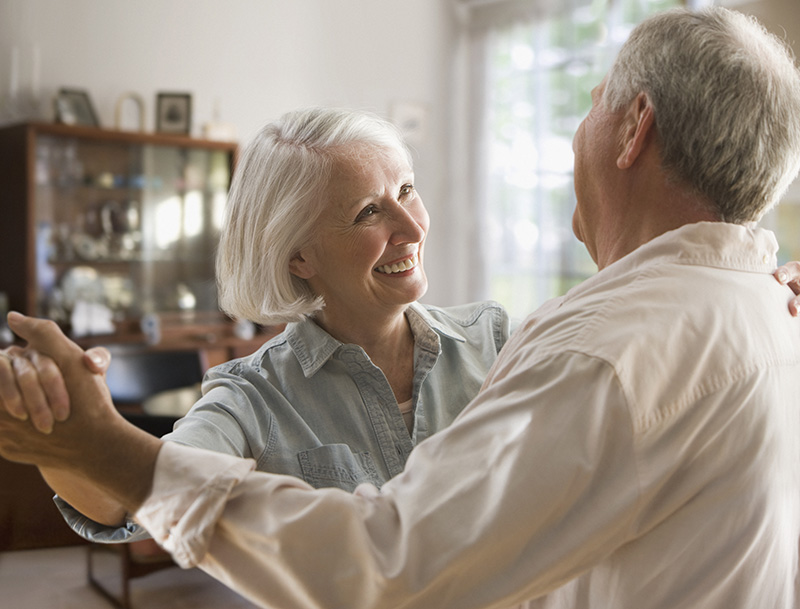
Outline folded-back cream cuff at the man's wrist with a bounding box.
[134,442,256,569]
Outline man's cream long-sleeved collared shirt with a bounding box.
[137,223,800,609]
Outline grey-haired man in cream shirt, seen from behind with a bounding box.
[0,8,800,609]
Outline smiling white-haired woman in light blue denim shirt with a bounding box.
[0,109,509,541]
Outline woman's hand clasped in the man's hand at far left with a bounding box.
[0,338,111,434]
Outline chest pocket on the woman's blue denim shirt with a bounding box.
[297,444,382,492]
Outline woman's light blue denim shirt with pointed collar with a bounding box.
[56,302,510,542]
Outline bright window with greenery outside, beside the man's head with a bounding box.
[483,0,682,317]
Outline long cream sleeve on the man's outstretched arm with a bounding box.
[136,354,638,609]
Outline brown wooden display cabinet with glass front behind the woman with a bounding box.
[0,123,272,551]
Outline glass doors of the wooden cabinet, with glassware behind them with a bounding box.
[34,134,233,335]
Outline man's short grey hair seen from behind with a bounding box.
[604,7,800,223]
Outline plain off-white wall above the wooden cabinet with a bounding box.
[0,0,462,302]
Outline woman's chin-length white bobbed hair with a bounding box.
[216,108,412,324]
